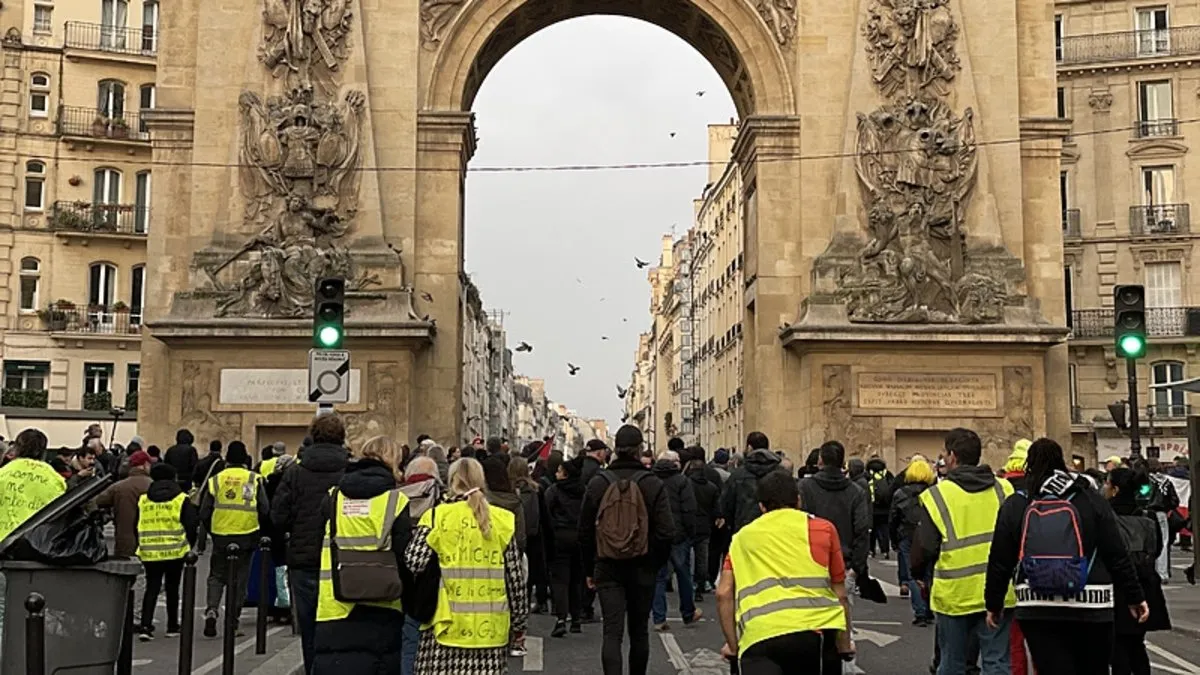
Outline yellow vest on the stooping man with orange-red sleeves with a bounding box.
[730,508,846,656]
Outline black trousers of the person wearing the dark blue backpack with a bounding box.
[1021,619,1112,675]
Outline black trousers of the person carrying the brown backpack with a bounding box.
[596,574,654,675]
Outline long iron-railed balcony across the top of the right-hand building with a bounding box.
[1057,25,1200,66]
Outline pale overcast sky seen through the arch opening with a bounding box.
[466,17,734,425]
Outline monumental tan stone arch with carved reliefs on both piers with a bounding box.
[139,0,1069,461]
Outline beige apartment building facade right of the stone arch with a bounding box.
[1055,0,1200,462]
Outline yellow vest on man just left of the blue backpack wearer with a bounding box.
[920,478,1016,616]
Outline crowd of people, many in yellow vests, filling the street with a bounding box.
[0,414,1189,675]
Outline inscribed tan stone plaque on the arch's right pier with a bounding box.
[857,372,1000,411]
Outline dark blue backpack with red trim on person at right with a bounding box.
[1018,482,1096,598]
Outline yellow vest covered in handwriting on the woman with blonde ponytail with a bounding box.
[420,501,516,649]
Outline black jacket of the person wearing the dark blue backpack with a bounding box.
[984,470,1145,623]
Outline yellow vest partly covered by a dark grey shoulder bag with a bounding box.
[317,488,408,621]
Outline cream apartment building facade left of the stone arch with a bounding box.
[0,0,157,443]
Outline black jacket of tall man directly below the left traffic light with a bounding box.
[271,443,349,572]
